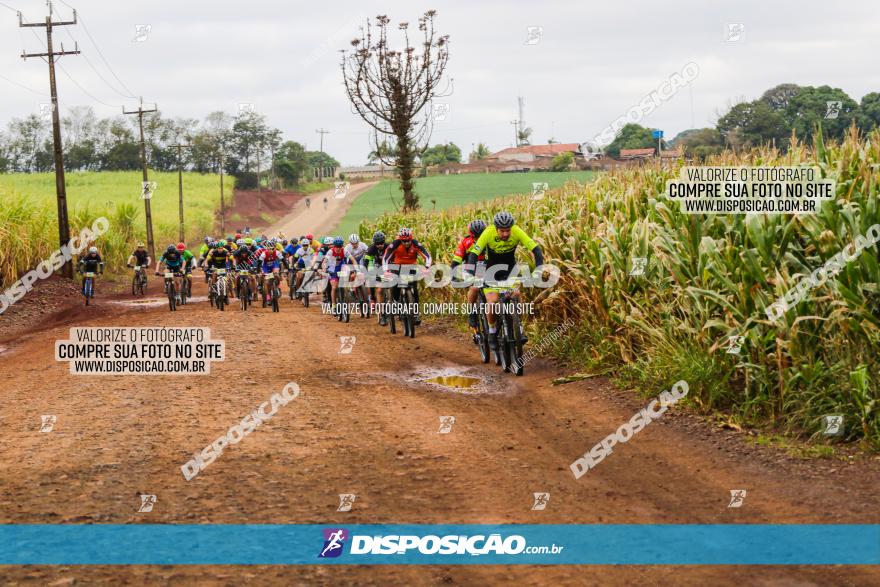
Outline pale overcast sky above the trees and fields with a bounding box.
[0,0,880,165]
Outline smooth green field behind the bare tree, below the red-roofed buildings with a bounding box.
[336,171,594,234]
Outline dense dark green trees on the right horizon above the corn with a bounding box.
[605,83,880,159]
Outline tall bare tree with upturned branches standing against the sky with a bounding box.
[342,10,449,210]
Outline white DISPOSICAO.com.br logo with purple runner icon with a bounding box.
[318,528,564,558]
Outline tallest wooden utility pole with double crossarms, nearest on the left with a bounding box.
[18,2,79,279]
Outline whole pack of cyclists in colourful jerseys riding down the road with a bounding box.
[79,212,543,360]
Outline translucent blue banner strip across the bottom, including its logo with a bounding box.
[0,524,880,565]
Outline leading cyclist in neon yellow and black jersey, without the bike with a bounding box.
[467,212,544,350]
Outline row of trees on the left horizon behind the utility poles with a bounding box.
[0,106,339,188]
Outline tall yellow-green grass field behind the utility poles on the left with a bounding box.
[0,171,234,280]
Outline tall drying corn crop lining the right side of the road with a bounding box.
[360,129,880,449]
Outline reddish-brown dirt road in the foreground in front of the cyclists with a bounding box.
[0,284,880,585]
